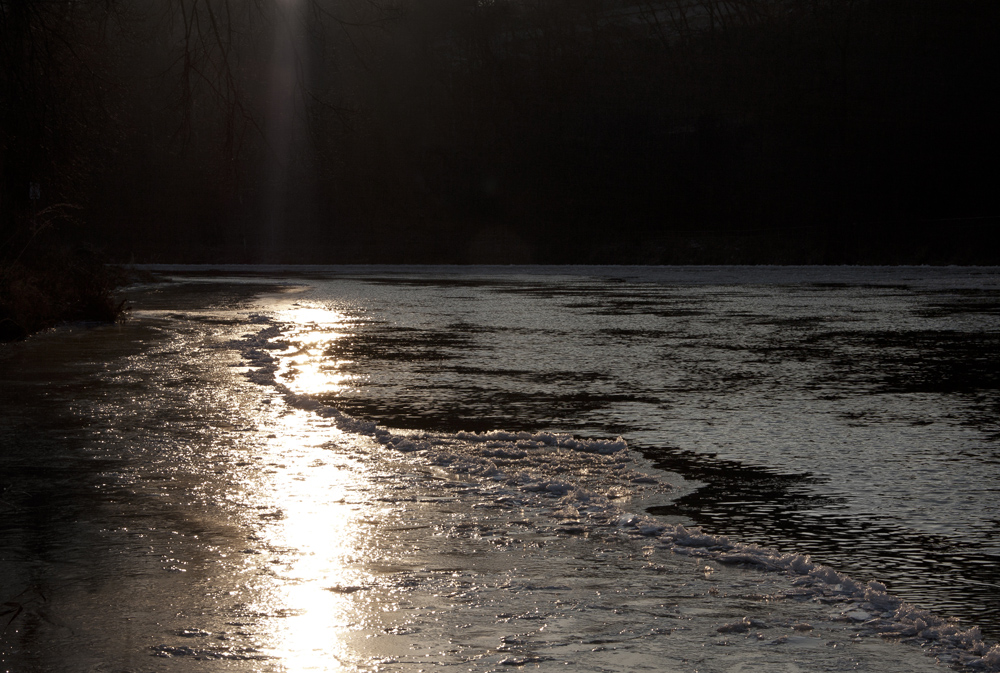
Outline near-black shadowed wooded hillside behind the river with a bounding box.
[0,0,1000,265]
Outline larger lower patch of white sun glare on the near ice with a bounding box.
[248,411,372,672]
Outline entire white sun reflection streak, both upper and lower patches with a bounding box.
[252,304,372,671]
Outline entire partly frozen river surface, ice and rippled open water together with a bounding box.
[0,267,1000,672]
